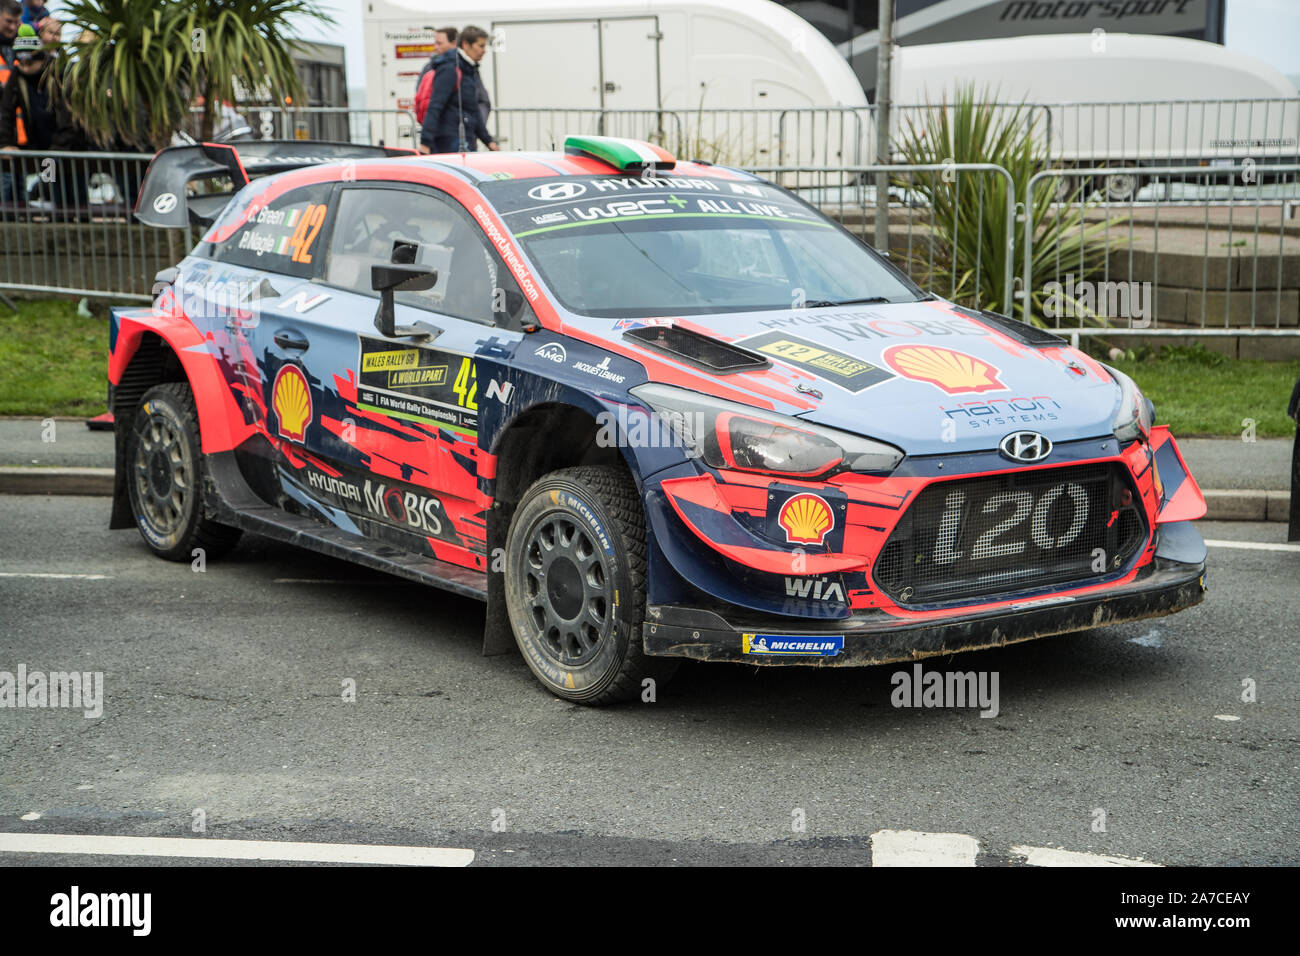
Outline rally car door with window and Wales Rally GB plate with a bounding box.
[269,182,533,568]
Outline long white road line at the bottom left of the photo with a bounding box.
[0,834,475,866]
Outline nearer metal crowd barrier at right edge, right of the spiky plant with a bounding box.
[1017,161,1300,336]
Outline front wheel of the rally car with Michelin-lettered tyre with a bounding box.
[506,467,677,705]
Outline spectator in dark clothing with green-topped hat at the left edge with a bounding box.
[0,23,86,202]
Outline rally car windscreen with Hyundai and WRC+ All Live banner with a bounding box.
[482,177,918,319]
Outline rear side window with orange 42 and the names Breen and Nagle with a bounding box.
[211,183,333,278]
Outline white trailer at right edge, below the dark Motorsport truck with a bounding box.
[893,31,1300,165]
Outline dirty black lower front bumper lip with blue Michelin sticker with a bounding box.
[644,523,1205,667]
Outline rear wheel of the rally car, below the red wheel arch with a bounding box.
[126,382,241,561]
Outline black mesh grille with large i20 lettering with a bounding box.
[875,464,1147,605]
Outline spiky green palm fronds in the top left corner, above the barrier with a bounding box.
[60,0,334,150]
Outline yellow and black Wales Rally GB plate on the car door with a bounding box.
[356,336,478,434]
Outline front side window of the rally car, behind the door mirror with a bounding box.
[325,186,515,324]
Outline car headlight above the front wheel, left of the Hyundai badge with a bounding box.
[632,382,904,479]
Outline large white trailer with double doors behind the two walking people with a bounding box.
[365,0,867,165]
